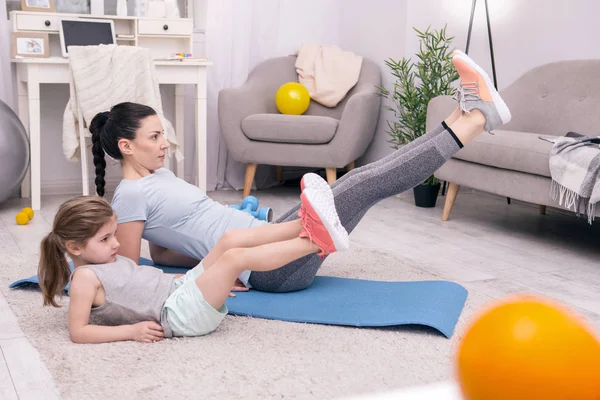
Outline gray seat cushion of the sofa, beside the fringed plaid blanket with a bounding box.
[454,129,552,177]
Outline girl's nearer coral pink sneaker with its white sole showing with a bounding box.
[300,187,350,258]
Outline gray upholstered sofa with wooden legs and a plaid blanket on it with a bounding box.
[427,60,600,221]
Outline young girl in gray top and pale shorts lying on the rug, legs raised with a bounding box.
[38,175,349,343]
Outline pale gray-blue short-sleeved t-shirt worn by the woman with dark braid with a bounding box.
[112,168,265,286]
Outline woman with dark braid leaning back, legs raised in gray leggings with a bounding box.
[90,53,511,292]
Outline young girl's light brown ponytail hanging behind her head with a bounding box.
[38,232,71,307]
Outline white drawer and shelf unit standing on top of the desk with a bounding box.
[10,11,194,58]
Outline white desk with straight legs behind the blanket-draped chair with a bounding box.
[12,57,212,210]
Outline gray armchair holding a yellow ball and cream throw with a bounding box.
[218,56,381,196]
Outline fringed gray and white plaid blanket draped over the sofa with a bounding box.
[540,132,600,224]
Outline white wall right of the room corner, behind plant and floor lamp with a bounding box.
[406,0,600,89]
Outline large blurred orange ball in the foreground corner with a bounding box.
[457,296,600,400]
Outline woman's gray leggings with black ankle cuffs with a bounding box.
[250,122,462,292]
